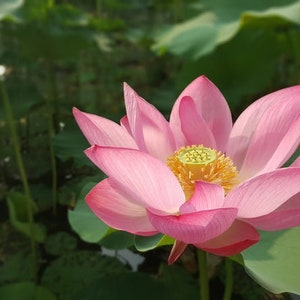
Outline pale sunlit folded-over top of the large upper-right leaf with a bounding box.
[153,0,300,59]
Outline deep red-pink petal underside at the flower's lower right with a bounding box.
[195,220,259,256]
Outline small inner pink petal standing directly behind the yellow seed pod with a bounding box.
[179,96,216,148]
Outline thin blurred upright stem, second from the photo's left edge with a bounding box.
[46,62,58,213]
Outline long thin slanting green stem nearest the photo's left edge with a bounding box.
[0,77,38,280]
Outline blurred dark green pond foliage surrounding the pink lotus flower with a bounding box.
[0,0,300,300]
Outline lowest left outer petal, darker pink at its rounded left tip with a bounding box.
[86,179,157,236]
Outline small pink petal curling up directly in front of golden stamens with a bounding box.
[180,181,224,214]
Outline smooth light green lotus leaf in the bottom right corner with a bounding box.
[242,227,300,294]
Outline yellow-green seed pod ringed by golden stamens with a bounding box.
[167,145,238,200]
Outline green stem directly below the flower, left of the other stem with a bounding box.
[197,249,209,300]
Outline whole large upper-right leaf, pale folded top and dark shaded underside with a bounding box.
[153,0,300,117]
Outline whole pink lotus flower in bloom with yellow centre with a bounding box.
[73,76,300,262]
